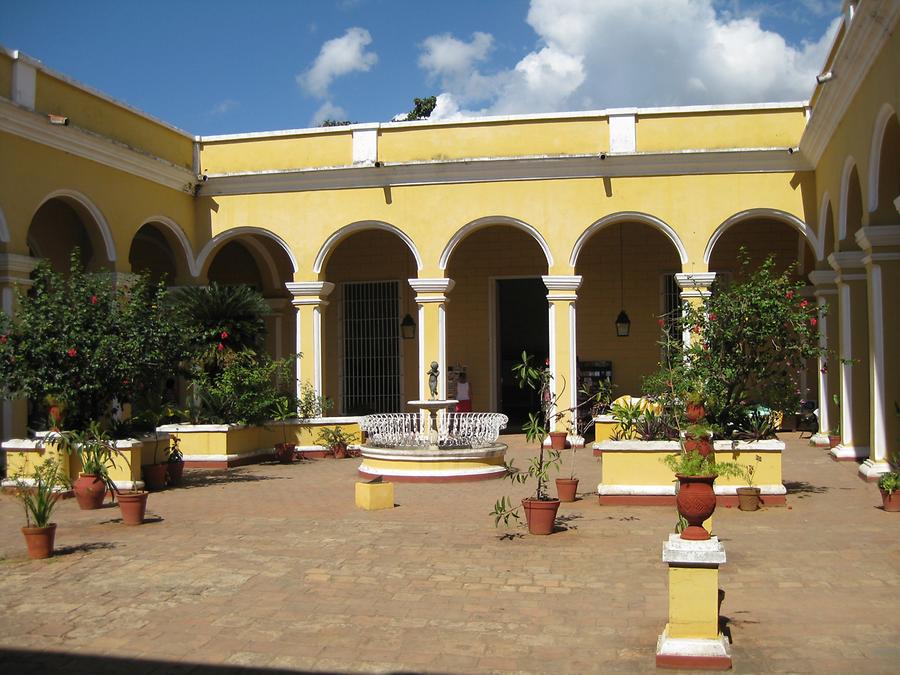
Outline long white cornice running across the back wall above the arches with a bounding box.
[199,148,812,197]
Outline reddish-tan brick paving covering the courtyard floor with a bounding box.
[0,434,900,675]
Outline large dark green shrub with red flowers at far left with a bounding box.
[0,250,186,429]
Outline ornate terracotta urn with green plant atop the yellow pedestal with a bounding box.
[663,450,742,541]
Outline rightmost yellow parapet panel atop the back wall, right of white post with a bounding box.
[635,108,806,152]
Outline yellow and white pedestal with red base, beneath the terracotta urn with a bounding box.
[656,534,731,670]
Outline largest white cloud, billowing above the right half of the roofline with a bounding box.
[419,0,837,118]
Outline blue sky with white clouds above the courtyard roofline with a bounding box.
[0,0,840,134]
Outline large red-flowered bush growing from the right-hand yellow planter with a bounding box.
[644,250,822,435]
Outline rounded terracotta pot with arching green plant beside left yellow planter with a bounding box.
[53,420,122,510]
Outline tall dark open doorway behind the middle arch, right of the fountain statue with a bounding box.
[497,278,550,431]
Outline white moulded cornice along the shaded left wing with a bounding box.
[0,99,194,192]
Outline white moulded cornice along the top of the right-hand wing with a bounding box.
[800,0,900,164]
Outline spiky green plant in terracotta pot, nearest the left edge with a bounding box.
[16,459,68,559]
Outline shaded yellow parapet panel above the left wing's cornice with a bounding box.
[34,70,194,168]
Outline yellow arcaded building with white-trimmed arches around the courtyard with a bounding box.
[0,0,900,477]
